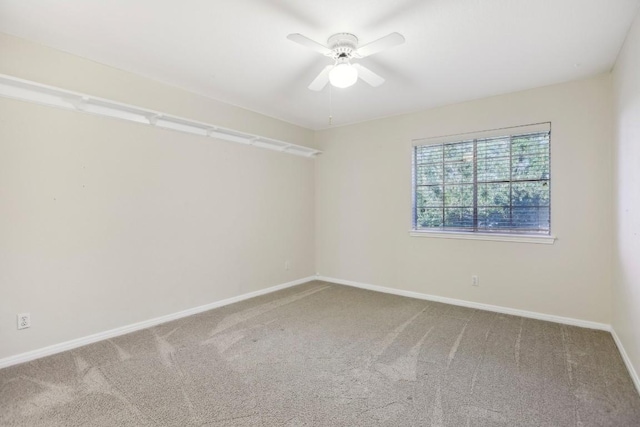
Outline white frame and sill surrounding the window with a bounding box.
[409,122,556,244]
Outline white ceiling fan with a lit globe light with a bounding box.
[287,33,404,91]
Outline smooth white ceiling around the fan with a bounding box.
[0,0,640,129]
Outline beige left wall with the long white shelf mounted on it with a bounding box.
[0,36,315,358]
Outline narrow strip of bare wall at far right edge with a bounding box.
[613,11,640,382]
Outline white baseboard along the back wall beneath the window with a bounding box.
[316,276,611,332]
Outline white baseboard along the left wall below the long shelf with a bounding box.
[0,276,316,369]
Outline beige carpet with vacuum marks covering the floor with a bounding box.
[0,282,640,427]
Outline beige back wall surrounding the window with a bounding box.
[316,74,612,323]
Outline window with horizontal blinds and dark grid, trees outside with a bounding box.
[413,123,551,235]
